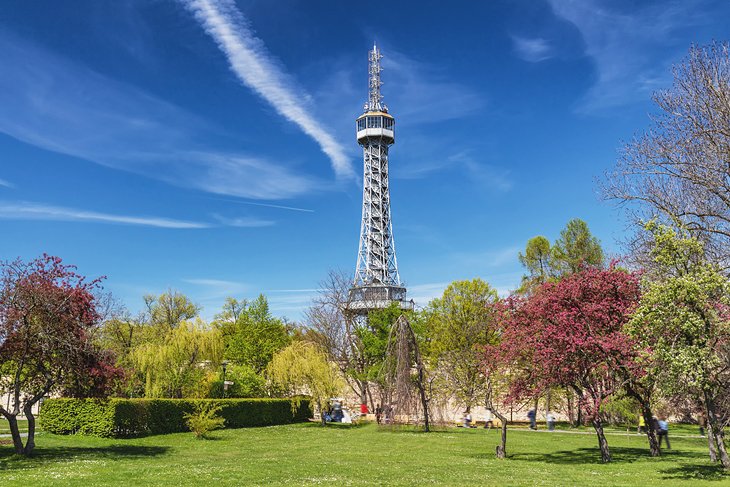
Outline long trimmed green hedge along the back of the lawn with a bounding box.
[38,398,312,438]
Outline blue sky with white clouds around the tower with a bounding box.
[0,0,730,320]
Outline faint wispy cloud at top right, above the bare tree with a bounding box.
[549,0,708,112]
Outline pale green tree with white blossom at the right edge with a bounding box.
[627,222,730,468]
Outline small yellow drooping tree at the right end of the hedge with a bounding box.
[268,341,344,426]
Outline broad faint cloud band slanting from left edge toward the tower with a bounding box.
[0,31,324,199]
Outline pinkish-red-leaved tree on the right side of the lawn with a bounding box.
[497,266,641,462]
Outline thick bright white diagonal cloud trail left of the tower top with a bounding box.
[181,0,355,178]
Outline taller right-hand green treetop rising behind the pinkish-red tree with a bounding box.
[550,218,604,276]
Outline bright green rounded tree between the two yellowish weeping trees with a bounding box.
[218,294,291,373]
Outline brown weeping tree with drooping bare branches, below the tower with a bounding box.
[380,315,430,431]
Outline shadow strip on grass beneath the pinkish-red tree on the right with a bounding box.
[507,446,704,465]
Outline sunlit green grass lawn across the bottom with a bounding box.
[0,423,730,487]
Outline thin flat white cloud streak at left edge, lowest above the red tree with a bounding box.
[0,202,210,229]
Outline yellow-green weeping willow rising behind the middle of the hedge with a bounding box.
[132,320,223,398]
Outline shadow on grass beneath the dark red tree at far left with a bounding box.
[0,445,169,471]
